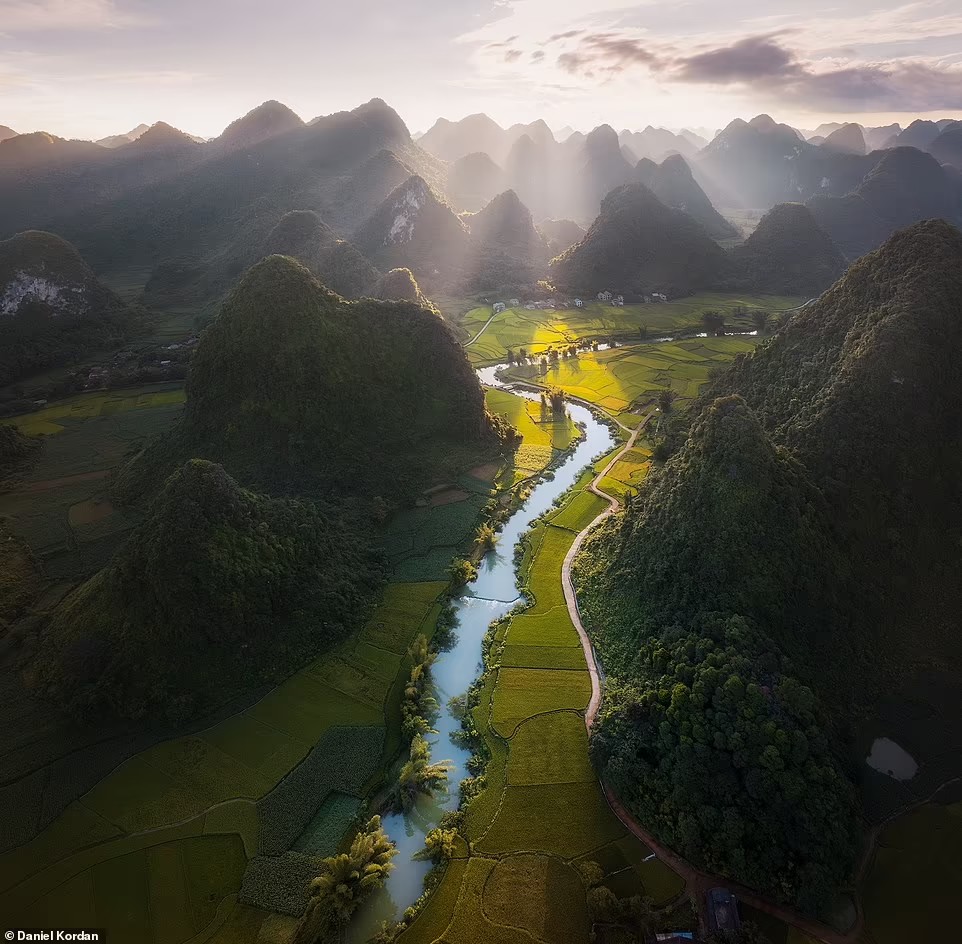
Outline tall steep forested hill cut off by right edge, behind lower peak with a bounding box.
[705,220,962,697]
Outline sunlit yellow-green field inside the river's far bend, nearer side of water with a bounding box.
[509,337,757,416]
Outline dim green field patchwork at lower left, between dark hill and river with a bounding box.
[0,581,448,944]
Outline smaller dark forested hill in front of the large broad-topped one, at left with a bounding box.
[30,460,383,724]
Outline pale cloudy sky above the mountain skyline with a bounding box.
[0,0,962,139]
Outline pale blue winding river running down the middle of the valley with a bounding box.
[349,365,615,944]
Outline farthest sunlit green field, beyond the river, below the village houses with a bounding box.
[455,292,805,365]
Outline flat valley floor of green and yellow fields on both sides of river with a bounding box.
[0,320,962,944]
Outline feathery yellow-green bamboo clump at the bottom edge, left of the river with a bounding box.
[292,816,397,944]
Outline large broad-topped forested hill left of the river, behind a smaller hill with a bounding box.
[120,256,496,496]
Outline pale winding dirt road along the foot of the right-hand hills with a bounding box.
[561,412,874,944]
